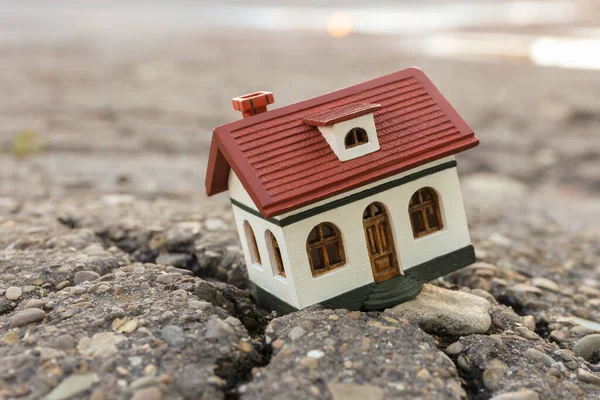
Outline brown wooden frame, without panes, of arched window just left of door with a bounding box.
[306,222,346,277]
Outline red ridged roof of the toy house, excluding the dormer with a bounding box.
[206,68,479,218]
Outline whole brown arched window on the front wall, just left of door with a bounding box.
[306,223,346,276]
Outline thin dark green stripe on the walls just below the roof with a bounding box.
[231,160,456,227]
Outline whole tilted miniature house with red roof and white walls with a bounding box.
[206,68,479,312]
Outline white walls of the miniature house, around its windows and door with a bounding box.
[230,157,471,308]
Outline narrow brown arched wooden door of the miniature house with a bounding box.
[363,203,400,282]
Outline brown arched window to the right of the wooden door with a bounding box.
[408,187,444,238]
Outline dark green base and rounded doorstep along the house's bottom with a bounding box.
[250,245,475,314]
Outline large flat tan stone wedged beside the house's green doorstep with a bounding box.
[387,284,492,336]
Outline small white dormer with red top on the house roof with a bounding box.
[302,103,381,161]
